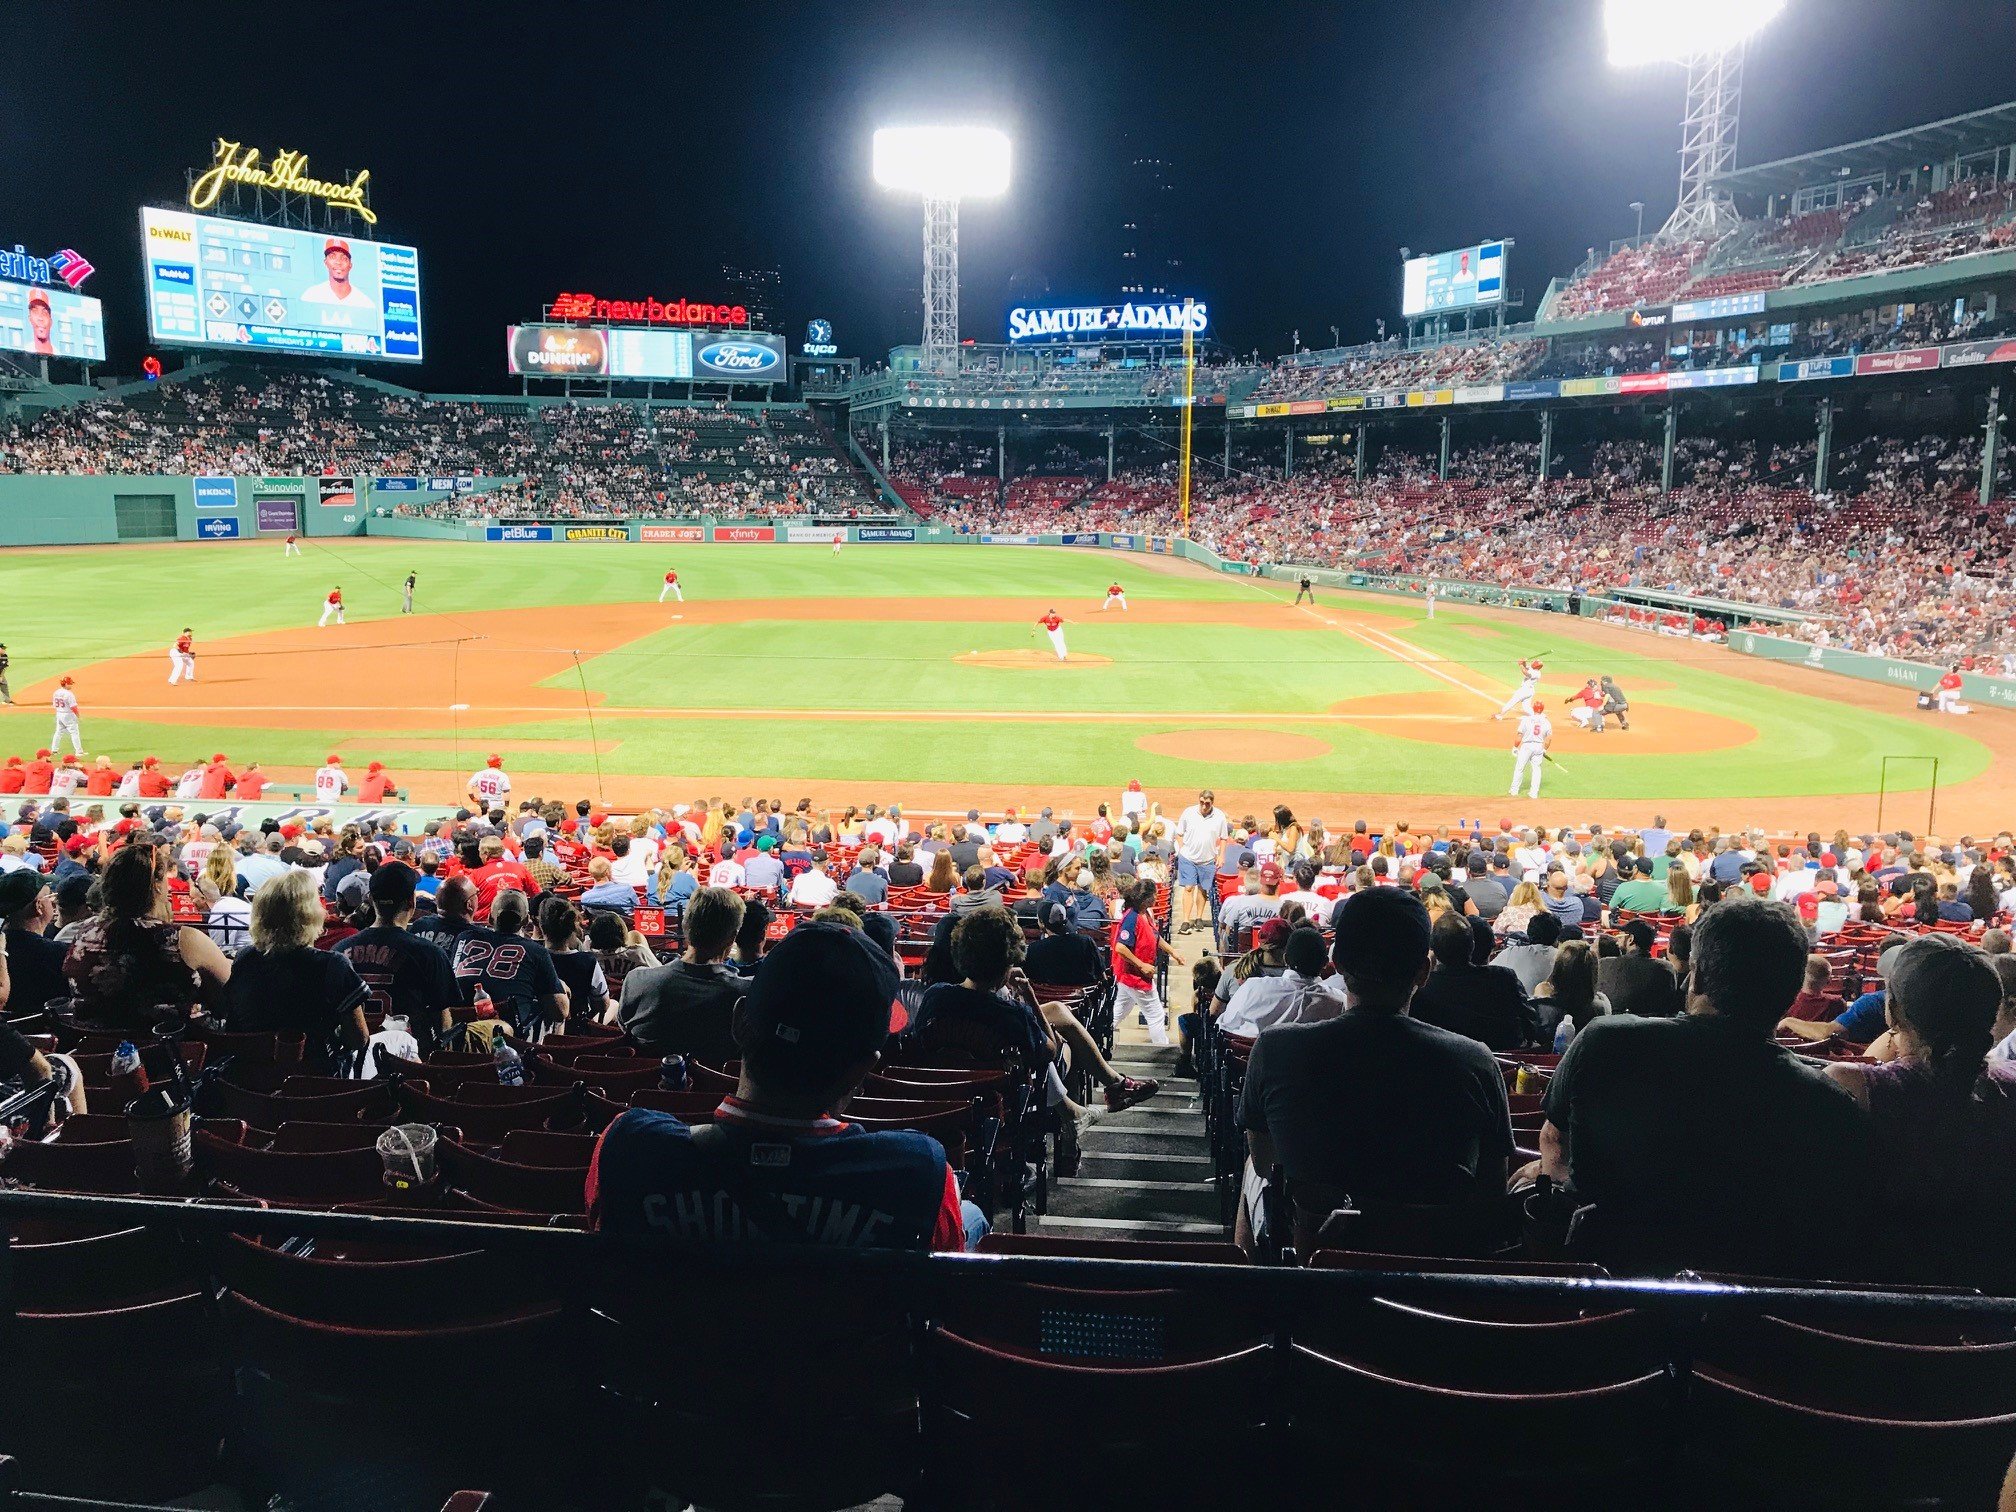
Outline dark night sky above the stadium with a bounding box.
[0,0,2016,391]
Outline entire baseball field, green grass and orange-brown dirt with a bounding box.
[0,538,2016,833]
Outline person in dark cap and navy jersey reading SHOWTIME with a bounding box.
[587,923,986,1250]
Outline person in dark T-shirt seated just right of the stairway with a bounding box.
[1238,887,1512,1244]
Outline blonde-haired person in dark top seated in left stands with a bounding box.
[224,871,371,1075]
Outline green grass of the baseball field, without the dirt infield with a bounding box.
[0,540,1992,800]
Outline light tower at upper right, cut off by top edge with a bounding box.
[1603,0,1786,242]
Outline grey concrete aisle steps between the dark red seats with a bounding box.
[1036,1024,1226,1240]
